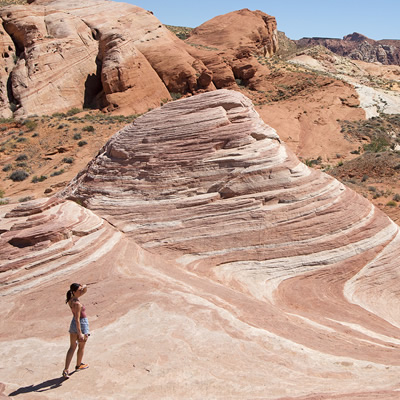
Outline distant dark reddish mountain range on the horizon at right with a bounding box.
[295,32,400,65]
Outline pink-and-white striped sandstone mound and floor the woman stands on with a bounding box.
[0,90,400,400]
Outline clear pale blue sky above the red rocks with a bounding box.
[117,0,400,40]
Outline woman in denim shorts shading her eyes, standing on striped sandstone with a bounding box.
[62,283,90,378]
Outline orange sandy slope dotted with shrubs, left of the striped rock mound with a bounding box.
[0,108,138,200]
